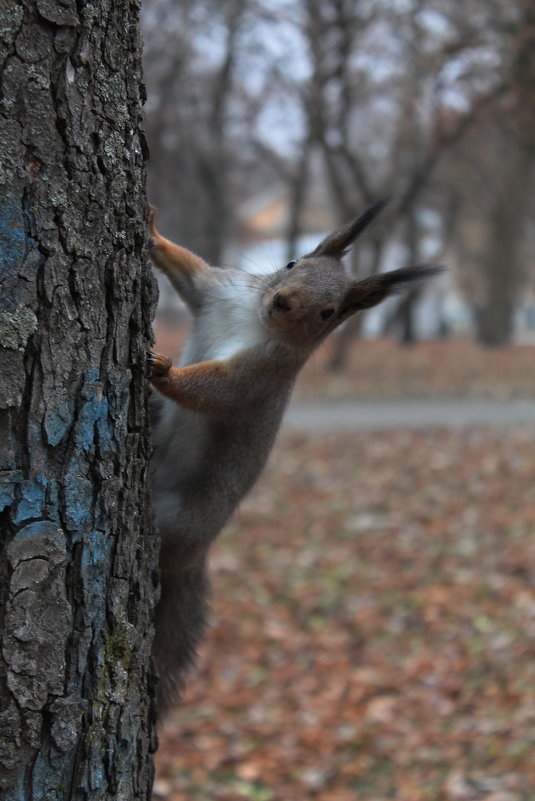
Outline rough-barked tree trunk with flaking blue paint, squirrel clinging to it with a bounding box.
[0,0,156,801]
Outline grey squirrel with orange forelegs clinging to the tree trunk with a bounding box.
[147,200,443,713]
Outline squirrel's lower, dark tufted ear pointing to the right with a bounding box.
[338,264,446,321]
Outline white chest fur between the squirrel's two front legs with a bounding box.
[180,270,270,366]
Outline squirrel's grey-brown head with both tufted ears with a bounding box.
[263,200,443,350]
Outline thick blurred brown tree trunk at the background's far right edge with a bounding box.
[452,0,535,346]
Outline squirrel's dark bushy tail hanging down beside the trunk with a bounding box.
[152,558,210,716]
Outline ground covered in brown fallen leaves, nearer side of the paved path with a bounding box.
[156,422,535,801]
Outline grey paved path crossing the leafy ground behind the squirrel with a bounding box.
[284,398,535,430]
